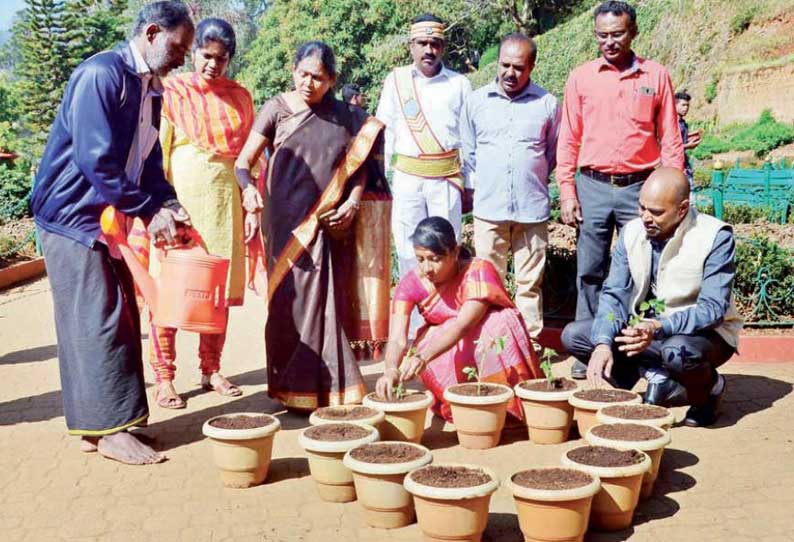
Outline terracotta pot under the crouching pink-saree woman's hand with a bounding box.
[362,390,433,443]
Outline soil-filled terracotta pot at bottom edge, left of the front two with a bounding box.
[404,464,499,542]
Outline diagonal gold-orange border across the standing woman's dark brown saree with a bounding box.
[267,117,383,302]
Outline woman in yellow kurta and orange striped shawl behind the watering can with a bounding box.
[149,15,262,408]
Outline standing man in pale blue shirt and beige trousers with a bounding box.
[460,34,561,345]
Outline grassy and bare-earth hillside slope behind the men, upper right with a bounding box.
[471,0,794,124]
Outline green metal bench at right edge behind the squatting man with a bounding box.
[695,162,794,224]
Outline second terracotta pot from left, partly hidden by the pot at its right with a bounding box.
[298,423,380,502]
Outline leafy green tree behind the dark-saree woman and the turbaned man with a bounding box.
[240,0,510,104]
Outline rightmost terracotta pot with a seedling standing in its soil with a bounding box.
[513,378,578,444]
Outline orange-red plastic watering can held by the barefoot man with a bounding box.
[99,206,229,333]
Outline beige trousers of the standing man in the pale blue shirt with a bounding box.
[474,217,549,339]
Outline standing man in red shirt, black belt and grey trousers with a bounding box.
[557,1,684,378]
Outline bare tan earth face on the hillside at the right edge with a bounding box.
[717,62,794,126]
